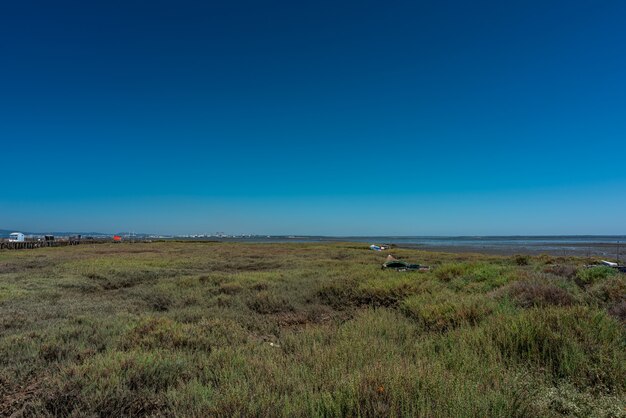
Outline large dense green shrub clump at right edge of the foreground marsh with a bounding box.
[489,306,626,390]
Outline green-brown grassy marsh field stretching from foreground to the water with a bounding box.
[0,242,626,417]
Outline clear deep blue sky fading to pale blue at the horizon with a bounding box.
[0,0,626,235]
